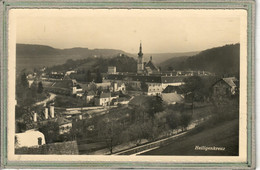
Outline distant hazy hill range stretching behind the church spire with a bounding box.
[16,44,198,72]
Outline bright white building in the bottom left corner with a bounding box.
[15,129,45,148]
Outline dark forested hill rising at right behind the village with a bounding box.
[160,44,240,75]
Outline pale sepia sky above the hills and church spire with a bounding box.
[11,9,245,53]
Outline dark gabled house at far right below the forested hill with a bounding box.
[212,77,239,100]
